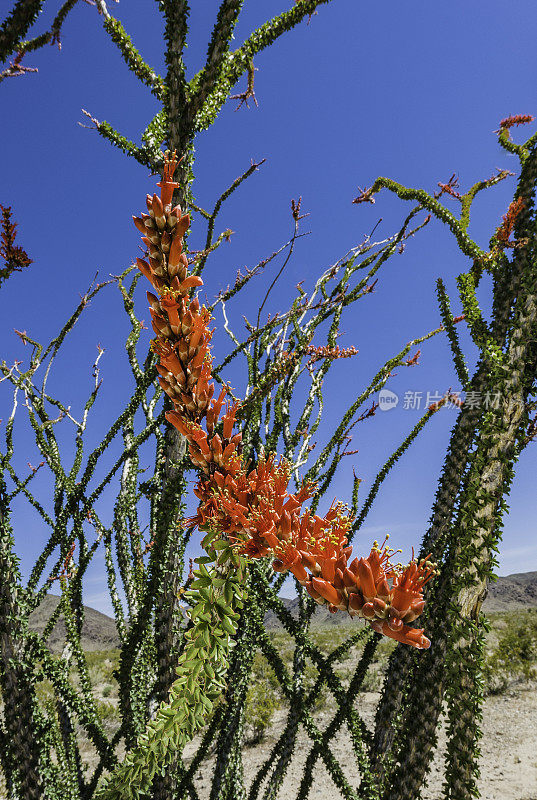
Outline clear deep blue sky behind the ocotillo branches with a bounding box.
[0,0,537,612]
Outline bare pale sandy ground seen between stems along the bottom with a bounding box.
[184,685,537,800]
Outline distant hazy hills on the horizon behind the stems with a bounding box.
[26,572,537,653]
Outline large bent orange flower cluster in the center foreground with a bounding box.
[134,154,434,648]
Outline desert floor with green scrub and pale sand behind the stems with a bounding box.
[0,608,537,800]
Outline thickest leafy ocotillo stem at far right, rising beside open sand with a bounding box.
[446,147,537,800]
